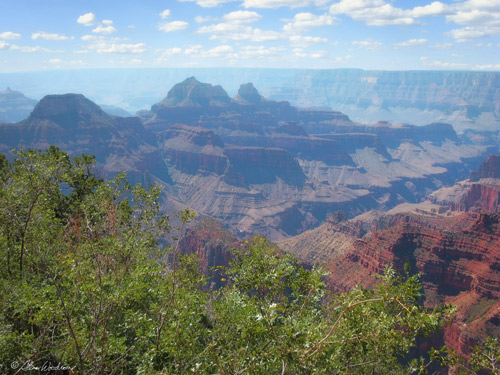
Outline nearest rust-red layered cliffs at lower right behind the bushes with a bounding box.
[328,212,500,355]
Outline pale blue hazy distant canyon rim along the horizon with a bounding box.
[0,68,500,133]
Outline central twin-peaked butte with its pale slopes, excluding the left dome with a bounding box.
[139,77,497,239]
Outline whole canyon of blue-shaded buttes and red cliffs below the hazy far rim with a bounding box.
[0,75,500,364]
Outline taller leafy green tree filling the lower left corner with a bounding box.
[0,147,205,374]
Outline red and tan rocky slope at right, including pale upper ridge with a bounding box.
[279,156,500,362]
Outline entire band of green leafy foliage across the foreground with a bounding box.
[0,147,462,374]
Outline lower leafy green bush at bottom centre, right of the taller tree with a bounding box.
[201,237,452,374]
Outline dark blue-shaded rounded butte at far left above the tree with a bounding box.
[0,94,170,182]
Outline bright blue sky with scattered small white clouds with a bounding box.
[0,0,500,73]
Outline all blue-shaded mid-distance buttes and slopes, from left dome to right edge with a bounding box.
[0,78,498,240]
